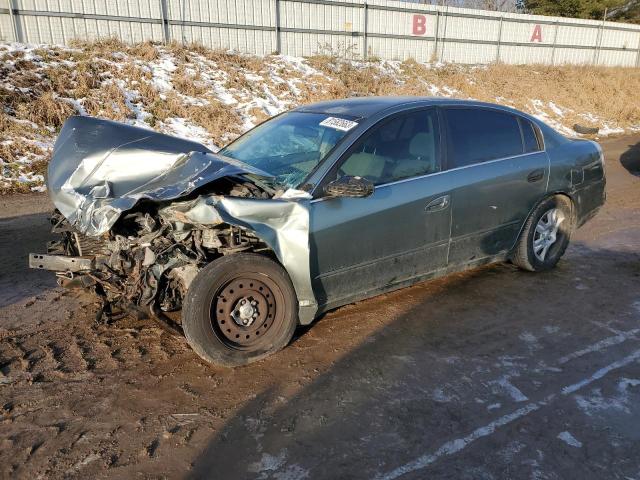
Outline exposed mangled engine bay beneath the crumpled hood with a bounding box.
[43,178,275,328]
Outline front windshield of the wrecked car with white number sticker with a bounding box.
[219,112,357,188]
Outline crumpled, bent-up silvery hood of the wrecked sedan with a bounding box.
[47,116,269,236]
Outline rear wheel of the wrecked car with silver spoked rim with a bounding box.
[511,195,574,272]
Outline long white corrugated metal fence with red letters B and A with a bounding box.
[0,0,640,67]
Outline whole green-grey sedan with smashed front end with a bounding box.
[30,97,605,365]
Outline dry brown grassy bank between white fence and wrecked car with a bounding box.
[0,39,640,191]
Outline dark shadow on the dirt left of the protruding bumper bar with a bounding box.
[0,213,56,307]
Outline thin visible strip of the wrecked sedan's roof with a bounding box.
[294,97,514,118]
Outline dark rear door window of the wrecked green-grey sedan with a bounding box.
[445,108,524,168]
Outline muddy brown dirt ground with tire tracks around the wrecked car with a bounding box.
[0,137,640,480]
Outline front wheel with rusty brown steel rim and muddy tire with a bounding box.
[182,253,298,367]
